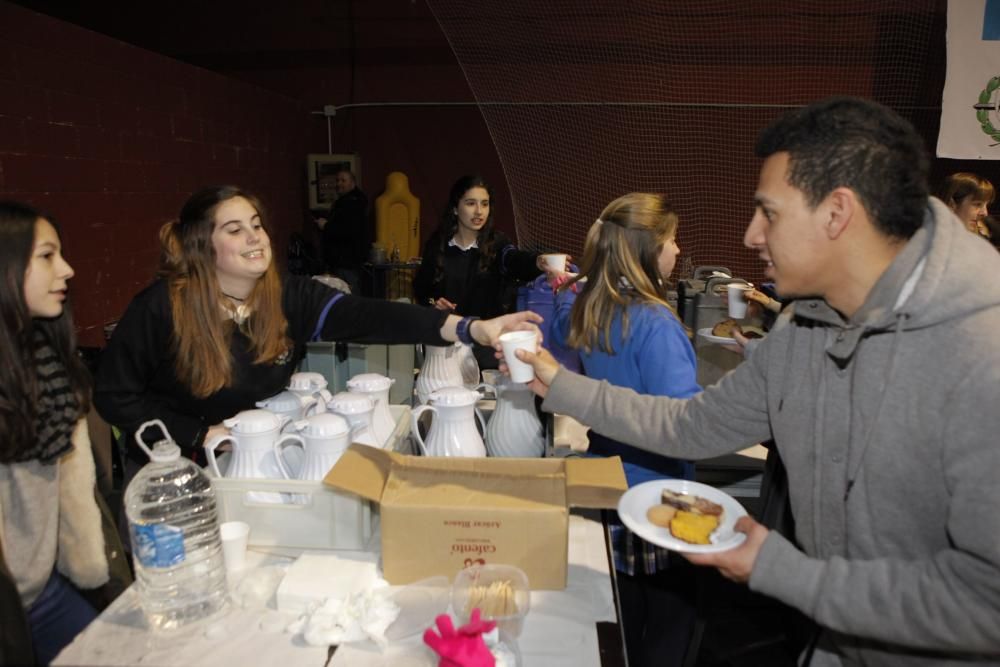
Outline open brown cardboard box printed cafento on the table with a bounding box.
[323,445,627,589]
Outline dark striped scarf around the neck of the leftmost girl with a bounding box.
[14,328,80,463]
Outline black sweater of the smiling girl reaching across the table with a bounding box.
[94,276,445,463]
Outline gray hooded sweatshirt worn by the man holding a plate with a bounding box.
[543,199,1000,667]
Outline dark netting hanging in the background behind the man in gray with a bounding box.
[428,0,944,279]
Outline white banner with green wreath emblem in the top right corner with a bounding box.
[937,0,1000,160]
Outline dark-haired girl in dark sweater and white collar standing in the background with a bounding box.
[413,175,542,368]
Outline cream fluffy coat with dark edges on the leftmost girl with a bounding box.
[0,419,132,664]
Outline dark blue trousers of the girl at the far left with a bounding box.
[28,570,97,665]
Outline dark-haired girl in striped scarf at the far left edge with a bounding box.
[0,202,129,664]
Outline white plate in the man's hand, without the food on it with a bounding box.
[618,479,747,554]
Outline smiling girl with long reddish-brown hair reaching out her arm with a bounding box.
[94,186,539,465]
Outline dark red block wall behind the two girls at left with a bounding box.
[0,3,309,345]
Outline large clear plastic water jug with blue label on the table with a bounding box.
[125,419,227,631]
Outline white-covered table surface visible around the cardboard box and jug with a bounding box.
[53,515,621,667]
